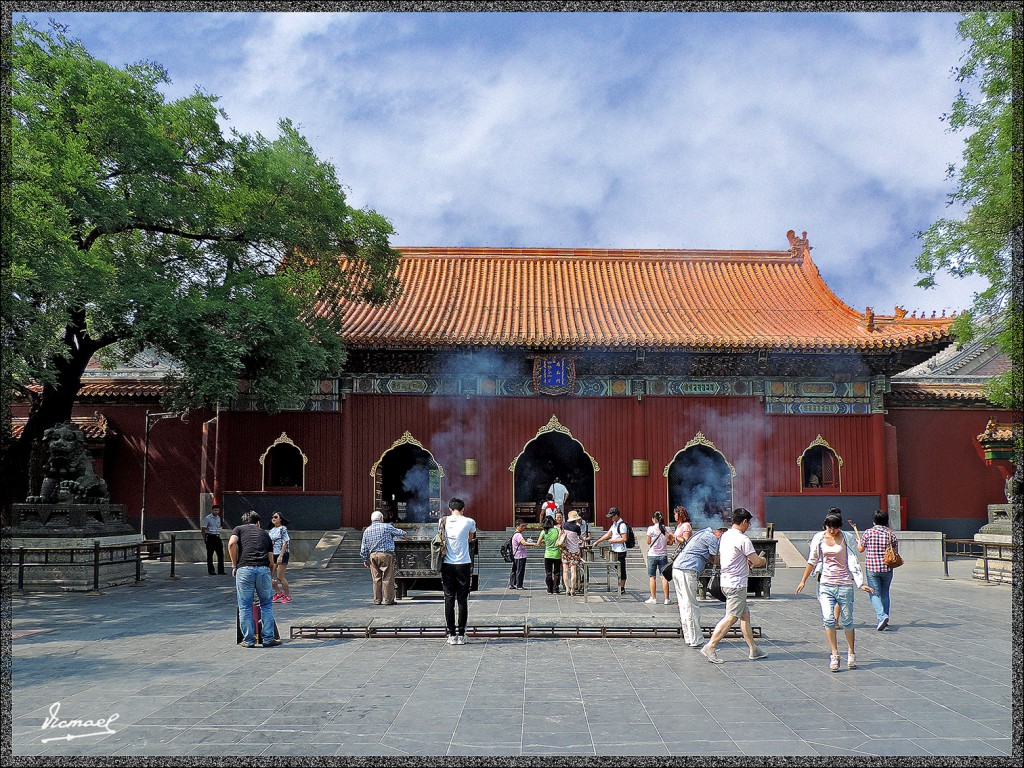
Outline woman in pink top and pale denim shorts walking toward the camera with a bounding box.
[797,511,874,672]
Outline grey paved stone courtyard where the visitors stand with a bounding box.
[11,561,1020,758]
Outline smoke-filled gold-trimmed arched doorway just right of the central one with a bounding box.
[665,432,736,528]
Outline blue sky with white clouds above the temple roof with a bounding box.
[14,12,983,314]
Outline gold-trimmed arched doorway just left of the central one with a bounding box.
[370,432,444,522]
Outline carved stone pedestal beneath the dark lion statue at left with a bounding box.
[3,504,143,592]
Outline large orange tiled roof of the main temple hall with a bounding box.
[337,232,951,350]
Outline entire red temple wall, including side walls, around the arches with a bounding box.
[15,395,1007,535]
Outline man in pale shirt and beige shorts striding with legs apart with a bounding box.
[700,508,768,664]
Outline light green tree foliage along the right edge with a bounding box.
[918,10,1024,410]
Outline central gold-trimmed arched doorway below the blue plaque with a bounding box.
[509,416,600,522]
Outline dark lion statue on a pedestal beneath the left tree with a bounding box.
[26,422,111,504]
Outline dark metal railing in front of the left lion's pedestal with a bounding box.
[3,534,177,595]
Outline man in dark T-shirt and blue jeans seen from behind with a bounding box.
[227,512,281,648]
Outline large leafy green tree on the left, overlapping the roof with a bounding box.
[0,22,399,501]
